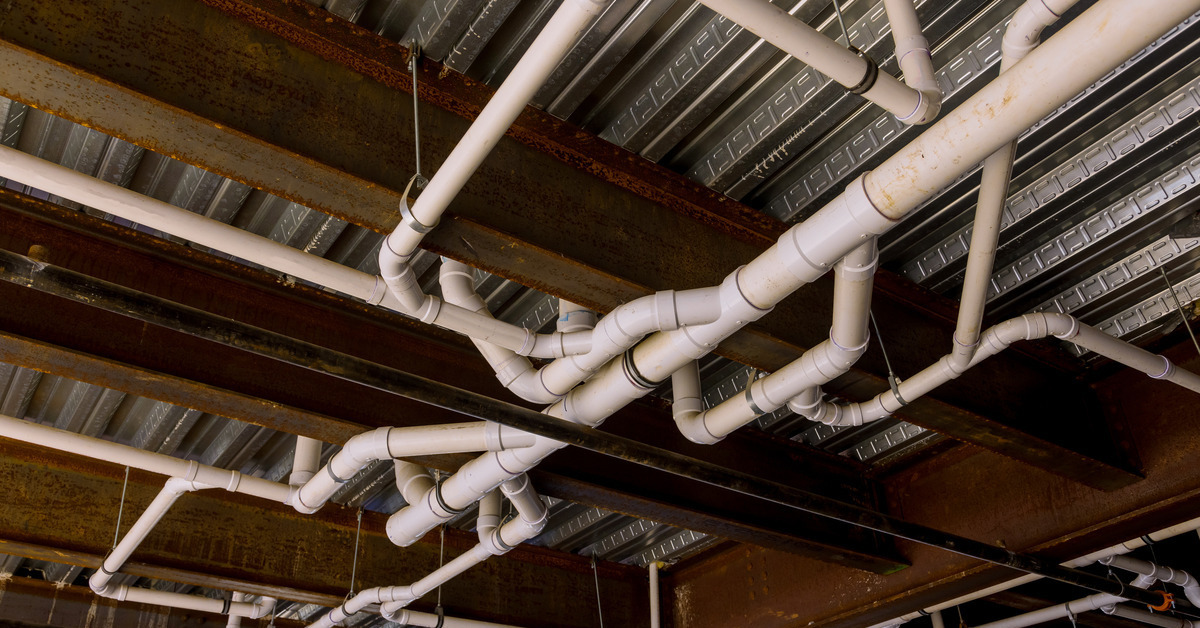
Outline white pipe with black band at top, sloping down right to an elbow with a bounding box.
[700,0,932,124]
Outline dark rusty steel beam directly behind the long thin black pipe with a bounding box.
[0,191,902,572]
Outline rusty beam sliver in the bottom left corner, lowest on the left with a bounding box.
[0,576,305,628]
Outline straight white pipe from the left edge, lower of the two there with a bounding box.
[0,414,293,503]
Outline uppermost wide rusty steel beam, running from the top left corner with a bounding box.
[0,0,1138,489]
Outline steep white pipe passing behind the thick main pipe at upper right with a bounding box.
[945,0,1078,370]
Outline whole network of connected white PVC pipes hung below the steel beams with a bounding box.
[0,0,1200,626]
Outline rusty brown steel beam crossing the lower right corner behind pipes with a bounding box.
[671,343,1200,628]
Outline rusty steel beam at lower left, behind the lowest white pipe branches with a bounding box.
[0,442,648,628]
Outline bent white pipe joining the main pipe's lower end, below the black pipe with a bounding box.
[293,421,536,514]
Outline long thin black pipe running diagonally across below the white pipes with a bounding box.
[0,251,1180,603]
